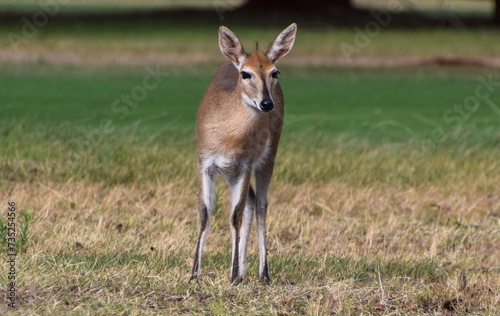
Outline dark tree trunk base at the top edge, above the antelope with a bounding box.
[243,0,352,12]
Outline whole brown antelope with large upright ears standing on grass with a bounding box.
[191,24,296,283]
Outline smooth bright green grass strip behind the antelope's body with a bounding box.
[0,66,500,145]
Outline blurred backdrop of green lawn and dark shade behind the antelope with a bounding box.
[0,0,500,145]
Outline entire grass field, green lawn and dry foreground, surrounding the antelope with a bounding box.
[0,4,500,315]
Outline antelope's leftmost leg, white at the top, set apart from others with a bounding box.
[189,163,215,281]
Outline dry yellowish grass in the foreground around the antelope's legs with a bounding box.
[0,129,500,315]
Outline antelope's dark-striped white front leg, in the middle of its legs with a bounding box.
[228,172,255,284]
